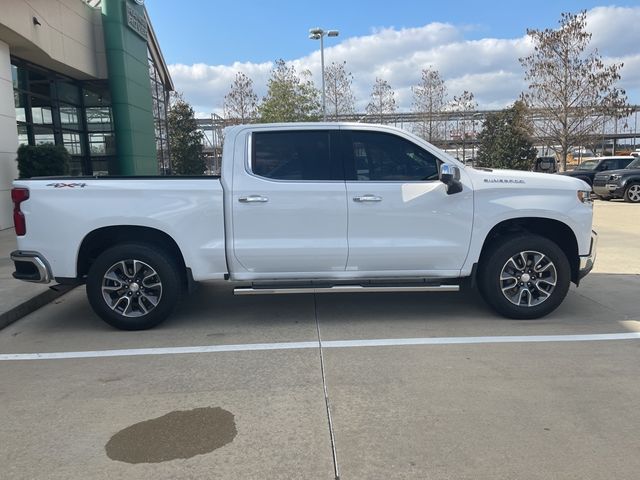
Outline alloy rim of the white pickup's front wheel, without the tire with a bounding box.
[500,251,558,307]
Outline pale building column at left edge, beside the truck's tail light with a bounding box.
[0,41,18,230]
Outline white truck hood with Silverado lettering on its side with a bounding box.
[467,167,591,191]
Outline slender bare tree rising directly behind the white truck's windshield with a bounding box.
[411,67,447,143]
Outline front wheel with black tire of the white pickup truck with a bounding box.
[478,234,571,319]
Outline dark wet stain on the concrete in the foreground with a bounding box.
[105,407,237,463]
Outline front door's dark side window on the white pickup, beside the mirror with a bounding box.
[346,131,438,181]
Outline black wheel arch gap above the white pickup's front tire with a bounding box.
[479,217,580,284]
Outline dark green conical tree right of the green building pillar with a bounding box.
[167,94,206,175]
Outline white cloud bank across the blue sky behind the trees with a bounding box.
[169,7,640,116]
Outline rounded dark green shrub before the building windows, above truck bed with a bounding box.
[17,143,70,178]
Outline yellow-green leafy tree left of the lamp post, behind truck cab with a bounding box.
[258,59,320,123]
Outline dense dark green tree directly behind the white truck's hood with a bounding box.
[476,100,537,170]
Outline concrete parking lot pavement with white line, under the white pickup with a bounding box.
[0,202,640,480]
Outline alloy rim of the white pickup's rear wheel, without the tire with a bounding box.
[102,259,162,317]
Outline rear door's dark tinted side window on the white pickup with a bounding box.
[251,130,336,180]
